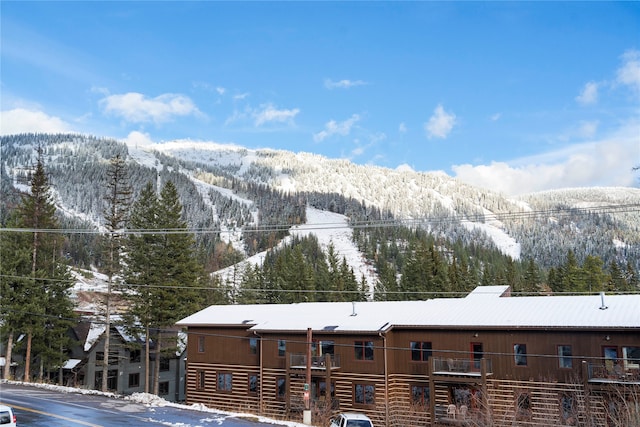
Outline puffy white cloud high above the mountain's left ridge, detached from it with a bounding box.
[100,92,202,123]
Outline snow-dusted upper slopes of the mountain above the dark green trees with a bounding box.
[1,134,640,277]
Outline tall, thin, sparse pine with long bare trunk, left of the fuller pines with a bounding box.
[102,155,132,392]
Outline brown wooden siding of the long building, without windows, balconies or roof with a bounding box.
[182,325,640,427]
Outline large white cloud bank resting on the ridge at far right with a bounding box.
[453,121,640,195]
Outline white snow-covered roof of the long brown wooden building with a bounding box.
[177,286,640,332]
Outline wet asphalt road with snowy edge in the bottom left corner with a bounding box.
[0,383,296,427]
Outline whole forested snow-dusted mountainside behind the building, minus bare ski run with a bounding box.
[0,134,640,302]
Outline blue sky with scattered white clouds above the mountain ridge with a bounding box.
[0,1,640,194]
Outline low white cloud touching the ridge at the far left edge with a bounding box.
[0,108,71,135]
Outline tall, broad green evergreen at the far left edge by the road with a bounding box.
[2,149,74,382]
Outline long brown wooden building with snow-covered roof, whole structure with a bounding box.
[178,286,640,426]
